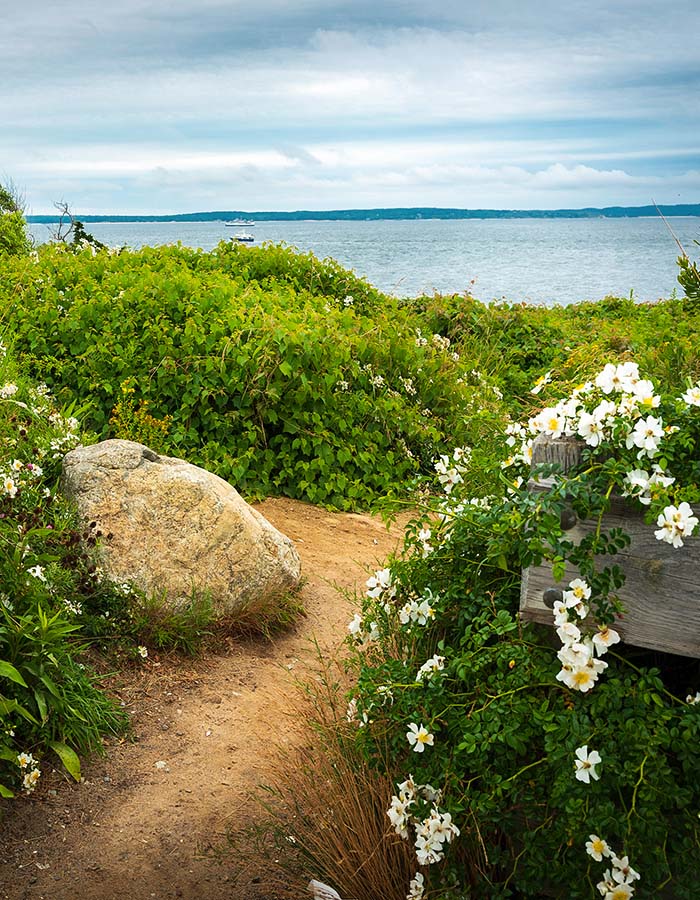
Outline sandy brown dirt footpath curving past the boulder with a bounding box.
[0,500,410,900]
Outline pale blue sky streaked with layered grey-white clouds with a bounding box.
[0,0,700,215]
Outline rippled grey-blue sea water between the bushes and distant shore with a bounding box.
[31,217,700,305]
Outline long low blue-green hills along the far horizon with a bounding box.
[27,203,700,223]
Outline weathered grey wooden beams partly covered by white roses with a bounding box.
[520,441,700,658]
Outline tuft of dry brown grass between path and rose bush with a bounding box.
[241,652,417,900]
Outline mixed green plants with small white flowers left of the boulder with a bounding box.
[0,356,126,797]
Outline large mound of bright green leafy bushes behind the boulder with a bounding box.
[0,244,502,508]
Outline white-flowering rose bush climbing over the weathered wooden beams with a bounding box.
[348,363,700,900]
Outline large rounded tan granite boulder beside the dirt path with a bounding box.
[61,440,301,617]
